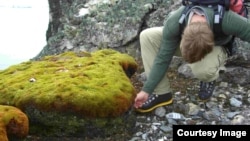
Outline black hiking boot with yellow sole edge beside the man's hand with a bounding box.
[136,93,173,113]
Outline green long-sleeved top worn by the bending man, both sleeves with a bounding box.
[142,6,250,94]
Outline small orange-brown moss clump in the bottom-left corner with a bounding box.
[0,105,29,141]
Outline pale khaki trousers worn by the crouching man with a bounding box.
[140,27,227,94]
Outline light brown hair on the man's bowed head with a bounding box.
[180,22,214,63]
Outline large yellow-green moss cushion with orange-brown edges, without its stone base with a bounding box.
[0,49,137,117]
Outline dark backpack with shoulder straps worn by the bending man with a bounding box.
[179,0,250,55]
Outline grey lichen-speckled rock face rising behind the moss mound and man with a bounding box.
[37,0,250,85]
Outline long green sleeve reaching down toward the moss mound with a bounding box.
[142,8,183,94]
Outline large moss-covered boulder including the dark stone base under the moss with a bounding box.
[0,49,137,137]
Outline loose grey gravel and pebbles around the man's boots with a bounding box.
[130,68,250,141]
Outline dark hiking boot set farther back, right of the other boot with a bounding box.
[198,81,215,101]
